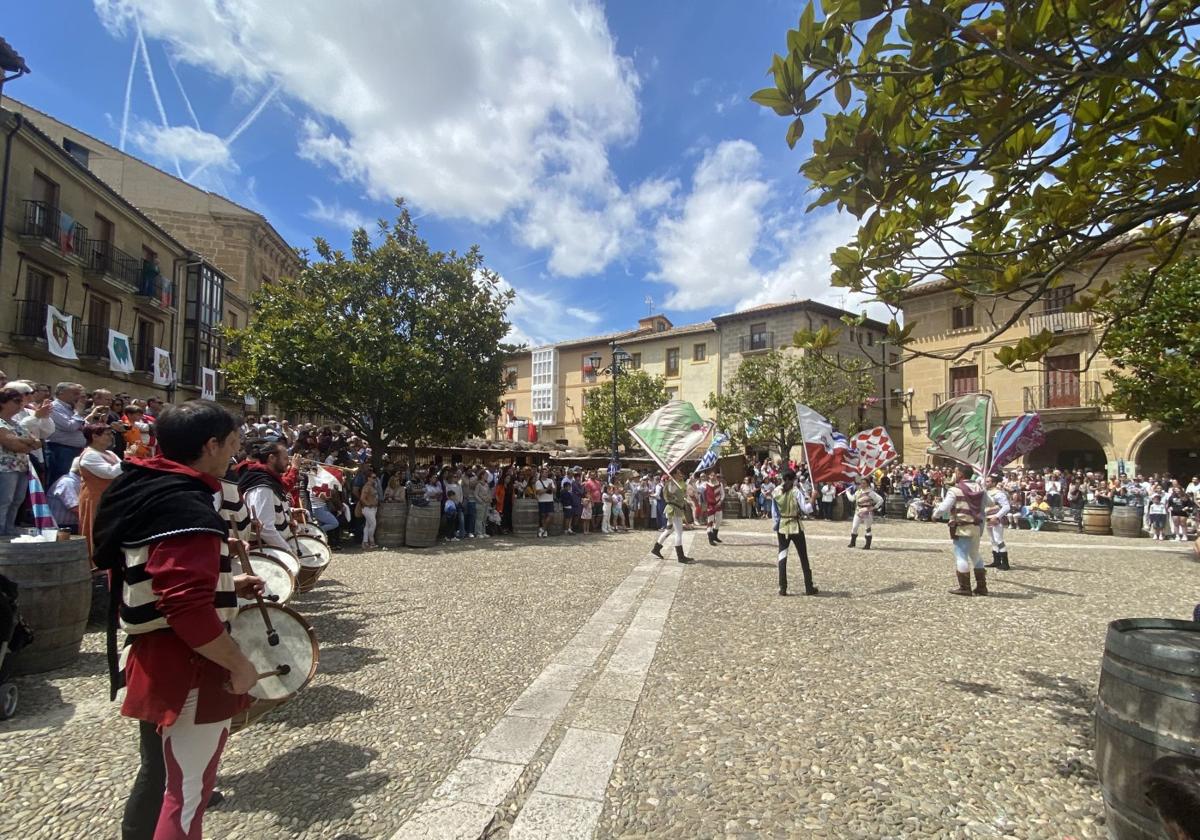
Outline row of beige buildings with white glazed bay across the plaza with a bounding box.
[496,300,902,456]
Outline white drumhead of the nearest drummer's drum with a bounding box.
[229,604,317,700]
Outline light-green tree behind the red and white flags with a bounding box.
[704,350,875,458]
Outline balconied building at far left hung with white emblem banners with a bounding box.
[0,110,219,398]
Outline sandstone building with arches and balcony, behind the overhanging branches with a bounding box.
[902,252,1200,480]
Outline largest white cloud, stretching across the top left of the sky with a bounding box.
[102,0,638,275]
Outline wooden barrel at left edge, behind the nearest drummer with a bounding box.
[0,536,91,673]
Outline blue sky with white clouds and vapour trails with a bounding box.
[0,0,874,346]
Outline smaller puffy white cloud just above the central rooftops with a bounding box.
[652,140,769,310]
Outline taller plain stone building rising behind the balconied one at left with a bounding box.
[5,97,300,402]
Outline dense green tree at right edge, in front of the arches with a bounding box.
[1097,257,1200,434]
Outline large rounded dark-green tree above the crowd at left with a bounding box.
[226,202,512,460]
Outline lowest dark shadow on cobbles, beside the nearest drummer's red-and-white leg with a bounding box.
[221,740,391,836]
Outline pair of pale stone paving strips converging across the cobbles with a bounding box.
[392,535,683,840]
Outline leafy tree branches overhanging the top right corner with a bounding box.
[750,0,1200,366]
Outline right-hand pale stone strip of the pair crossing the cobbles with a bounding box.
[509,547,690,840]
